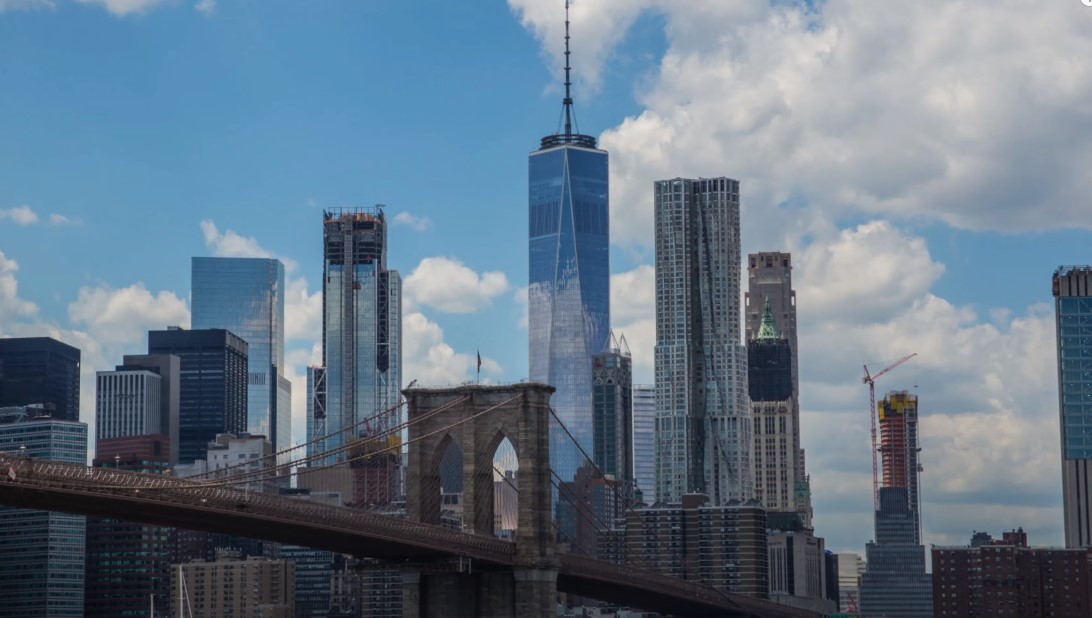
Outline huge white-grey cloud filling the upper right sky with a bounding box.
[509,0,1092,245]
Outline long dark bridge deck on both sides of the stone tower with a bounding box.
[0,455,817,618]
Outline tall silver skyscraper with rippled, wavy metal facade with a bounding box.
[654,177,755,504]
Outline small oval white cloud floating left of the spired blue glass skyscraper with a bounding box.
[404,258,510,313]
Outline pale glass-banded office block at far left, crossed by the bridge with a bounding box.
[0,407,87,618]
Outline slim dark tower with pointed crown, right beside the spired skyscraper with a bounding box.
[592,333,633,486]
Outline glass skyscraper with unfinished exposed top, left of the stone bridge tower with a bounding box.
[308,206,402,465]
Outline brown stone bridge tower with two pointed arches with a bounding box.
[403,383,559,618]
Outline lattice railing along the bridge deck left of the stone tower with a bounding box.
[0,456,515,564]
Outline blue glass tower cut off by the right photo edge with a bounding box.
[1054,266,1092,547]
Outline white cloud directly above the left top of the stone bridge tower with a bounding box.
[402,312,501,387]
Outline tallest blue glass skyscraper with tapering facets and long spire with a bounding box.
[527,3,610,478]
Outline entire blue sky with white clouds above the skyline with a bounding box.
[0,0,1092,554]
